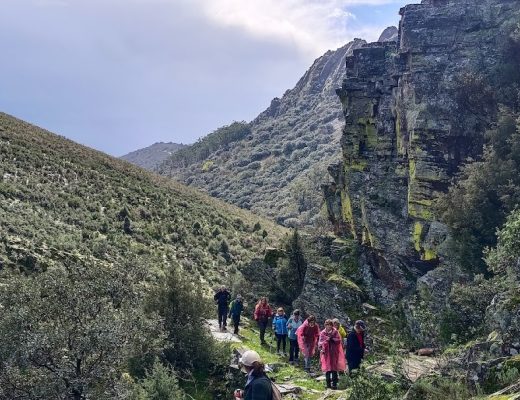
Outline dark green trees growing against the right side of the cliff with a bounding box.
[438,26,520,272]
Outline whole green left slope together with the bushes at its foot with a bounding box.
[0,114,285,400]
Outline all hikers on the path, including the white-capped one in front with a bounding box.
[215,286,367,400]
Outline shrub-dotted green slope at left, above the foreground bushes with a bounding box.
[0,113,285,284]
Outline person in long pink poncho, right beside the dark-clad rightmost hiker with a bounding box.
[318,319,345,390]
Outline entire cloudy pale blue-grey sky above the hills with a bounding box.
[0,0,418,156]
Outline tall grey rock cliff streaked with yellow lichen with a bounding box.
[324,0,520,303]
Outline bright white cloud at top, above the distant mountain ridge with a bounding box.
[189,0,402,55]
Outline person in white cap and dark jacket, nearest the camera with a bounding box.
[234,350,273,400]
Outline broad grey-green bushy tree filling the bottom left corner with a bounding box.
[0,259,161,400]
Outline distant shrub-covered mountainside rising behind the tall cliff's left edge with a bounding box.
[158,39,365,230]
